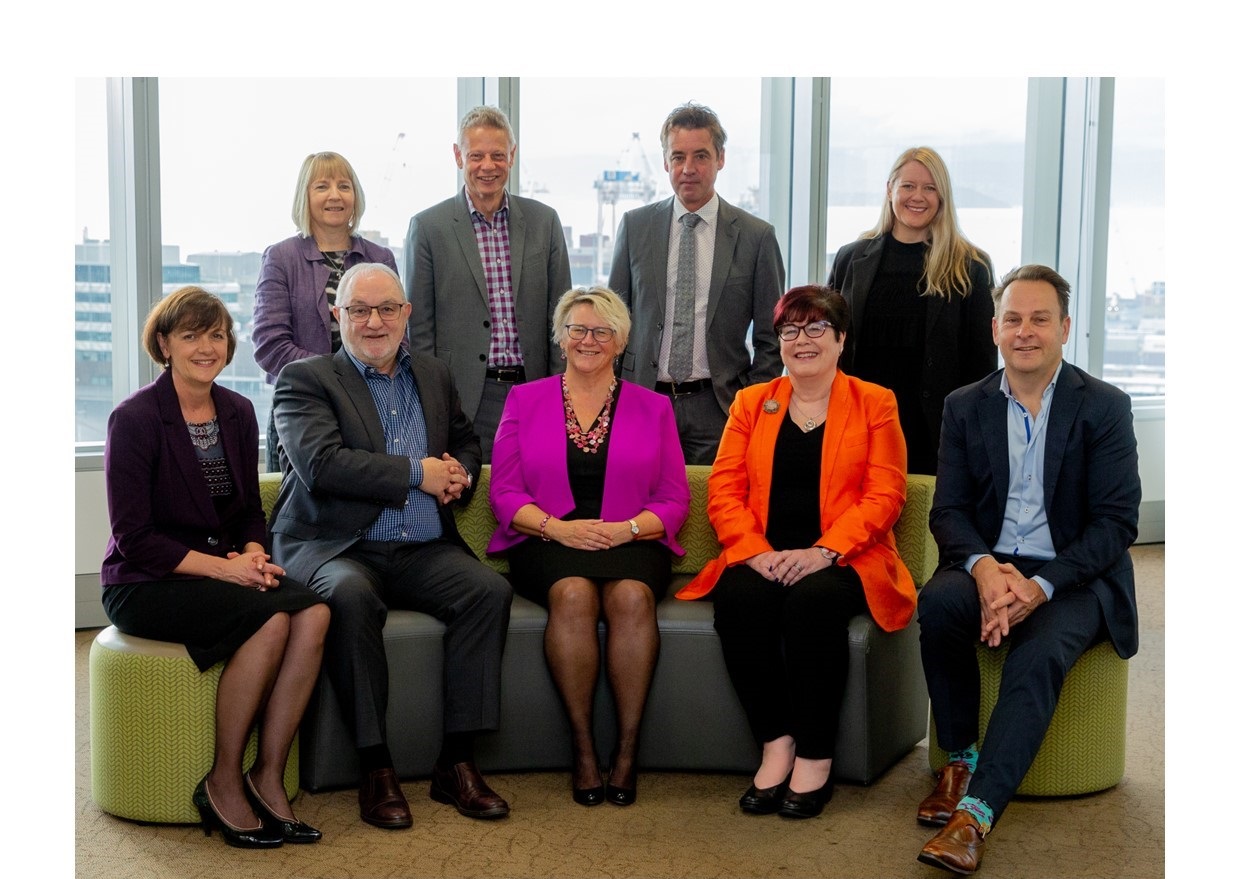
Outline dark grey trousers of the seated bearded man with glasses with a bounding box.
[309,541,512,748]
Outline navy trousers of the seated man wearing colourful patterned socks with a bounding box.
[918,555,1106,821]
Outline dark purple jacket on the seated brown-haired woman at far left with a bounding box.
[99,369,267,586]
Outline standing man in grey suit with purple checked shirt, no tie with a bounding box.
[404,107,573,462]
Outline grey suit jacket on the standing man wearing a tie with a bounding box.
[608,196,784,412]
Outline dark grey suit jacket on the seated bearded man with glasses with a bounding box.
[270,350,482,583]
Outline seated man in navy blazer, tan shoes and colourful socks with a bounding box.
[918,265,1141,873]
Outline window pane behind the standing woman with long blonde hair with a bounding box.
[827,78,1028,282]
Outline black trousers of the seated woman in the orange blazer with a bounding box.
[711,564,869,760]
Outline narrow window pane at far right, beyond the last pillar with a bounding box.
[1102,77,1167,397]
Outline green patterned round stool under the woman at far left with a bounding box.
[91,626,300,824]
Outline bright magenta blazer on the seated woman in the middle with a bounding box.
[486,376,689,555]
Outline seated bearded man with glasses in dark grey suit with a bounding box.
[270,263,512,828]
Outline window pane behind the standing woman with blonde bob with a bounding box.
[159,78,456,438]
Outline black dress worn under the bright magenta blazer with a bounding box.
[508,383,672,607]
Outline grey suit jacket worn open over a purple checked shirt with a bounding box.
[404,187,573,417]
